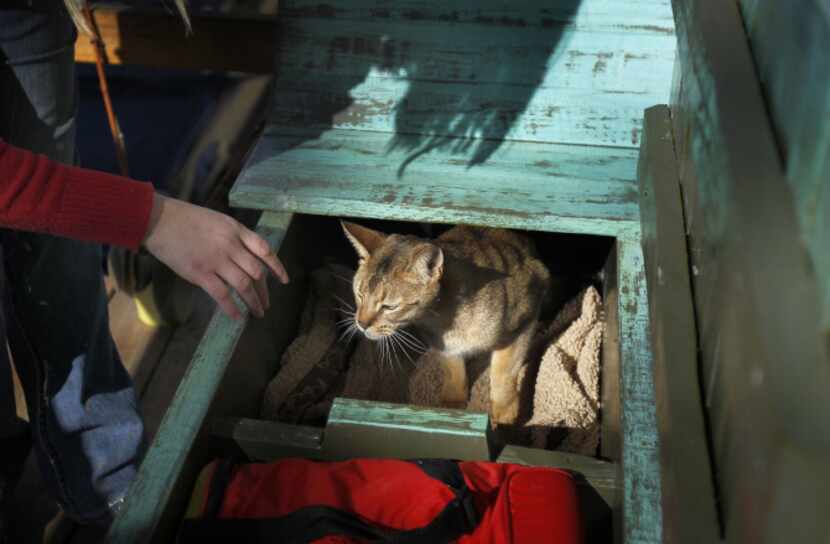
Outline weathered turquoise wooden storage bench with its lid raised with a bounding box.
[111,0,676,542]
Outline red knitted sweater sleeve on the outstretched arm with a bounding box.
[0,140,154,249]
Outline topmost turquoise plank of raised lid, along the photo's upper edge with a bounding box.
[280,0,674,33]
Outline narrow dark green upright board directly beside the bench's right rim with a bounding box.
[639,106,720,544]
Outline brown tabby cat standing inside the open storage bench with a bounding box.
[341,221,550,424]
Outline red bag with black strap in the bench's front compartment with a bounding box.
[179,459,583,544]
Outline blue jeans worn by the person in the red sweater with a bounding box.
[0,0,146,523]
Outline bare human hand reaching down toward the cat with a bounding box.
[143,193,288,319]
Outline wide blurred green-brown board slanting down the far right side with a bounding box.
[672,1,830,542]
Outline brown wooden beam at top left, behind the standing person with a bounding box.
[75,7,277,73]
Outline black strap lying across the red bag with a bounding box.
[179,459,479,544]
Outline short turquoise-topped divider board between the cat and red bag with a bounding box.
[323,398,490,461]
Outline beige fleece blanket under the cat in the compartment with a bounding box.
[262,266,604,455]
